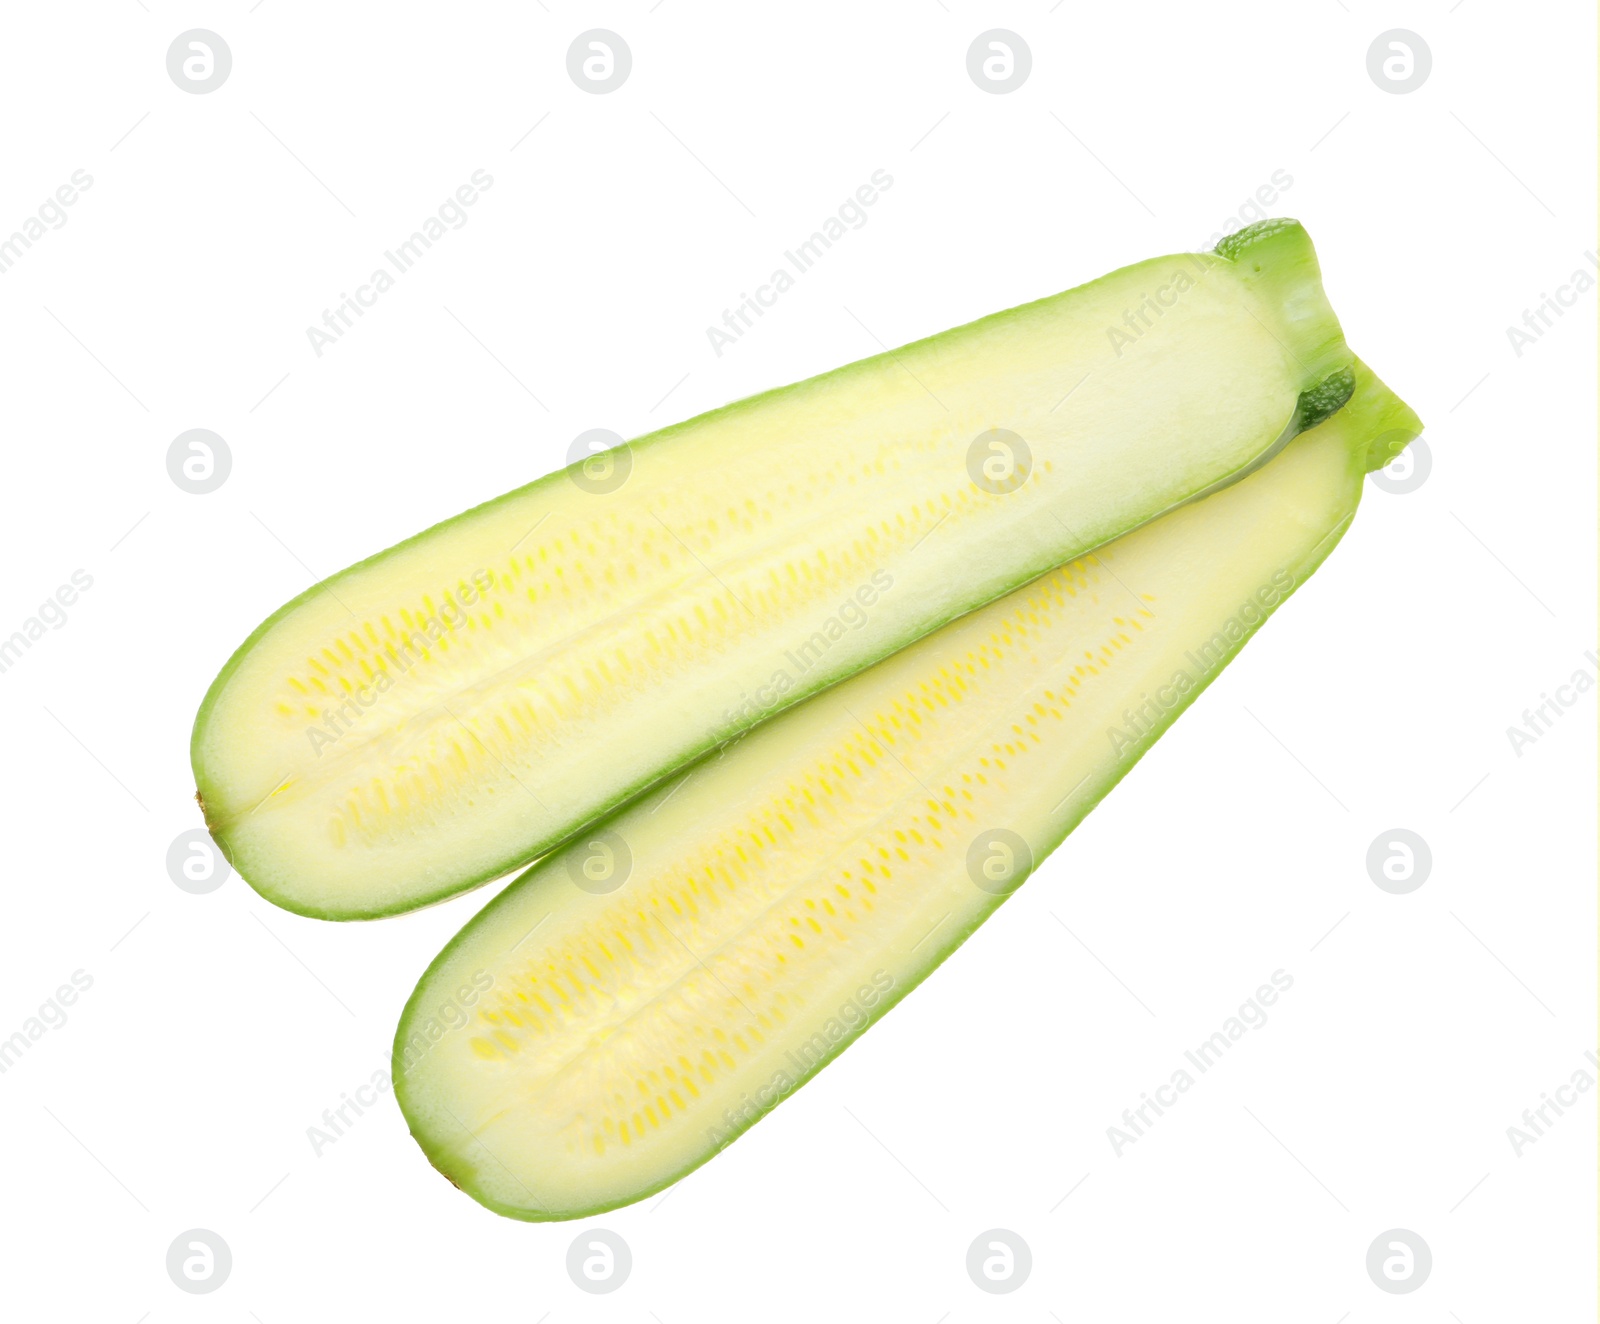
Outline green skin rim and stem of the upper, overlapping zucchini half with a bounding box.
[190,222,1352,921]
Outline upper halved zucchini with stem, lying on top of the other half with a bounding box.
[192,222,1350,919]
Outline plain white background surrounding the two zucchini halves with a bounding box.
[0,0,1600,1324]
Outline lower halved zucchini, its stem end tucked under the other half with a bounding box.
[394,368,1421,1220]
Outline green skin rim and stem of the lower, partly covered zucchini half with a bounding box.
[392,365,1421,1222]
